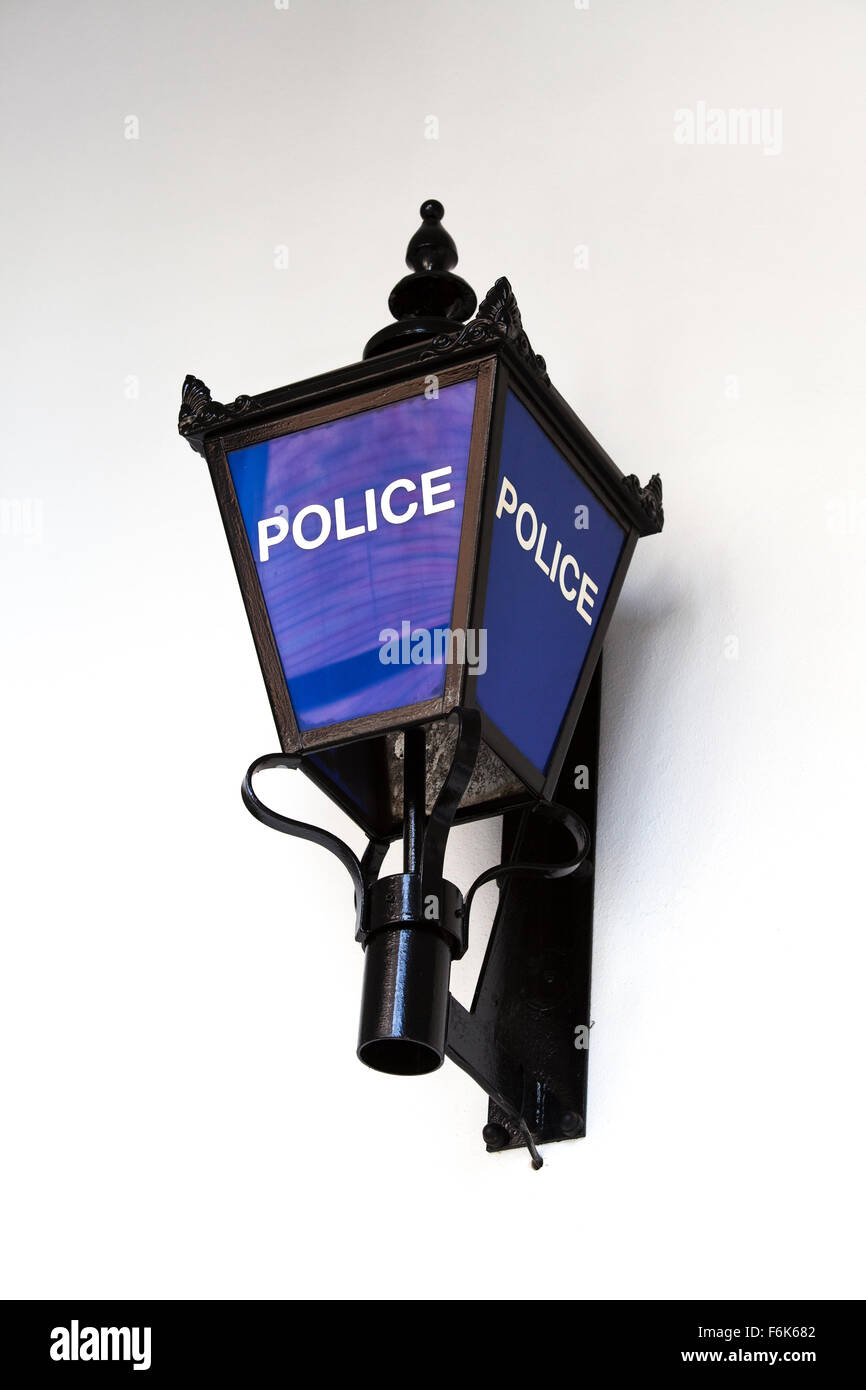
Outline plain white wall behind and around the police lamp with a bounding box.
[0,0,866,1298]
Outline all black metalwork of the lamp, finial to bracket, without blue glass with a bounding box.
[178,236,663,1168]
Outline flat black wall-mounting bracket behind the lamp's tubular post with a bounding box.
[448,664,602,1152]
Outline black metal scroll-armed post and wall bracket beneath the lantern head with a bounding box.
[240,692,601,1169]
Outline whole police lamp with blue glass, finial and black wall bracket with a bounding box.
[179,202,663,1166]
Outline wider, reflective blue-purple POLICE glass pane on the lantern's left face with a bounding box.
[228,379,475,730]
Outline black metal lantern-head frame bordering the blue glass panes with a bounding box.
[179,281,663,838]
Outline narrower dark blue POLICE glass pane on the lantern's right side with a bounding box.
[475,392,626,771]
